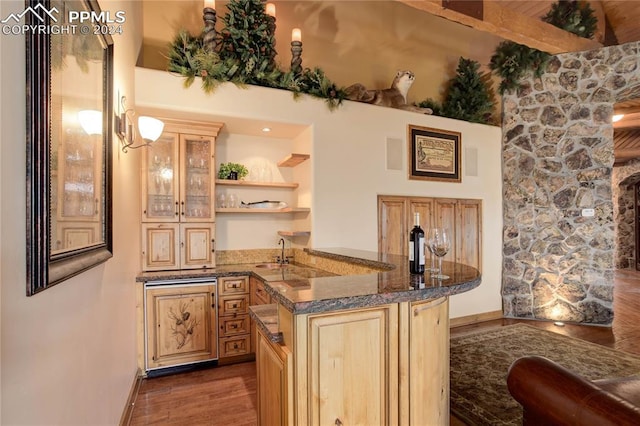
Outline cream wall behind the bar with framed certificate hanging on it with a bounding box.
[136,68,502,317]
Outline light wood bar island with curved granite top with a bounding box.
[250,248,481,426]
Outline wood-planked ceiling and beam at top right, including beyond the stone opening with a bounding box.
[397,0,640,164]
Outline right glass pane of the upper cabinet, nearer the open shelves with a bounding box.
[184,137,212,218]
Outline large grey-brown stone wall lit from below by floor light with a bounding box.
[502,43,640,324]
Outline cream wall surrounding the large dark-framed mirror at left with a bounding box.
[0,0,141,425]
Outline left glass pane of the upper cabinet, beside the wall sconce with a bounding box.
[146,134,177,218]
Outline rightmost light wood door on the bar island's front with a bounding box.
[400,298,449,425]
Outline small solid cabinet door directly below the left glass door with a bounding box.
[142,223,180,271]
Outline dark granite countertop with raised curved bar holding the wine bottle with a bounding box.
[136,248,481,314]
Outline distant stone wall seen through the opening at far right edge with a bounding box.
[611,159,640,268]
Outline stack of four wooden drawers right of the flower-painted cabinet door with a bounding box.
[218,276,252,362]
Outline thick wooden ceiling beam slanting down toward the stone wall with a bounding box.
[396,0,602,55]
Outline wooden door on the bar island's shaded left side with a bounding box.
[256,332,293,426]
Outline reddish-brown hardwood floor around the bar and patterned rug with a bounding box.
[126,270,640,426]
